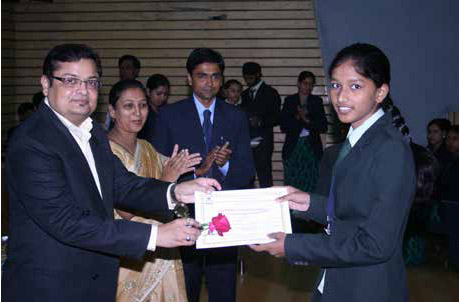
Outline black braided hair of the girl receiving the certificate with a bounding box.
[329,43,409,136]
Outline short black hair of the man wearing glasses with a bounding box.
[43,44,102,83]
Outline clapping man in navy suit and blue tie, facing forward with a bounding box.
[153,48,254,302]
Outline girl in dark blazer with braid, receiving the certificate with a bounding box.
[251,43,416,302]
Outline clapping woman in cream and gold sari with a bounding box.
[108,80,201,302]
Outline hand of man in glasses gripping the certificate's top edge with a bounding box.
[174,177,222,203]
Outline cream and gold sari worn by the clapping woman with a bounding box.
[110,139,187,302]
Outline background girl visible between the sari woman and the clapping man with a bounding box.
[137,74,170,144]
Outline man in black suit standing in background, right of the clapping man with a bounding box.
[241,62,281,188]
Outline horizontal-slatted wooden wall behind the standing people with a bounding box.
[2,0,342,184]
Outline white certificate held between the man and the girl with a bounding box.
[195,187,292,249]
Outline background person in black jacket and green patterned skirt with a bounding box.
[280,71,327,192]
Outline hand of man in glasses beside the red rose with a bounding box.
[156,218,201,248]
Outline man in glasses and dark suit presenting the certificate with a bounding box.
[2,44,219,302]
